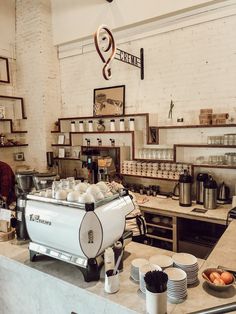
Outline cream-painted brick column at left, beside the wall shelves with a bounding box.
[13,0,60,171]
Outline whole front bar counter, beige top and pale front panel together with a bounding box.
[0,220,236,314]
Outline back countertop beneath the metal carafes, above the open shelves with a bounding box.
[136,194,232,224]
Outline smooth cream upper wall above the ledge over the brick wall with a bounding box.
[51,0,227,45]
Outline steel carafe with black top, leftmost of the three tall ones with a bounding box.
[179,170,192,207]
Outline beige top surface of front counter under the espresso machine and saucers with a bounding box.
[0,220,236,314]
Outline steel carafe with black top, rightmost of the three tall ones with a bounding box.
[203,176,217,209]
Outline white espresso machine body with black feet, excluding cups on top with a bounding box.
[25,190,134,281]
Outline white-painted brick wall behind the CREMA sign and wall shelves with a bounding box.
[60,16,236,194]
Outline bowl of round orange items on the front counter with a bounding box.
[202,268,235,291]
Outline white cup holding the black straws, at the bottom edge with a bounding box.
[146,289,167,314]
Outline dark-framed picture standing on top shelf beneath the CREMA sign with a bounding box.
[93,85,125,117]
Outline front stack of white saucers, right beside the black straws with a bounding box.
[164,267,187,303]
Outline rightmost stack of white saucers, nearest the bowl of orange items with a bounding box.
[172,253,199,286]
